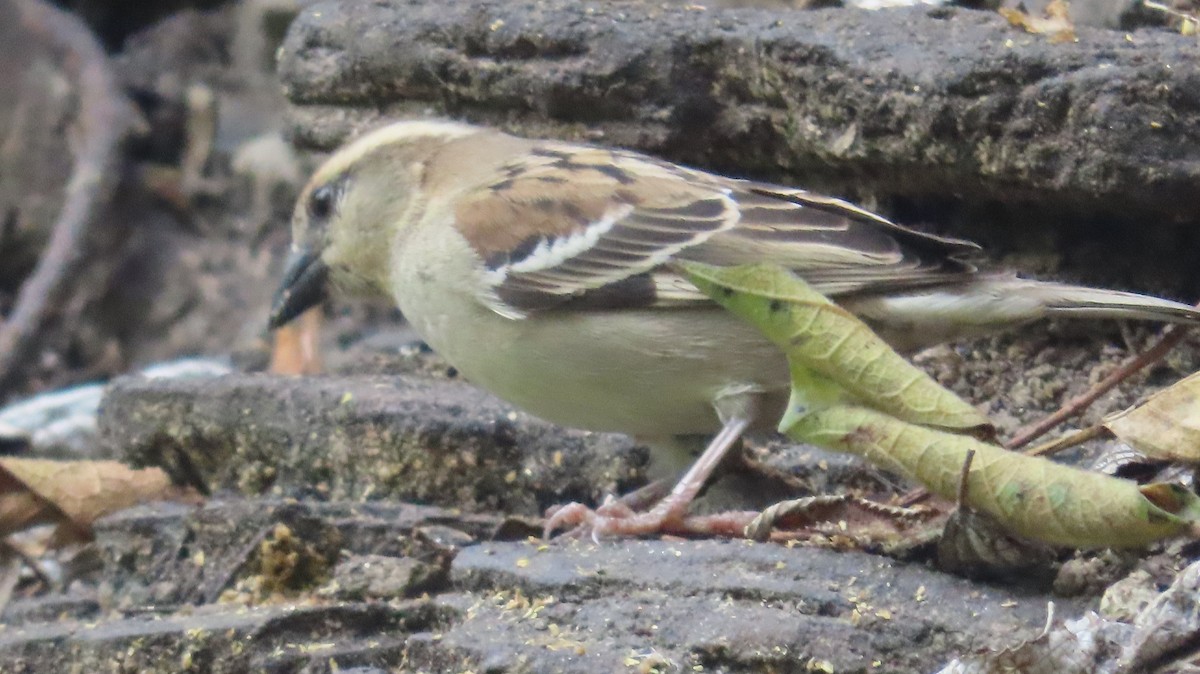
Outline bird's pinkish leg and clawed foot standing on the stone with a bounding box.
[545,393,757,538]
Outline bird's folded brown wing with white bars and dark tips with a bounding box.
[455,143,978,318]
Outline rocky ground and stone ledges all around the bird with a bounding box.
[0,0,1200,673]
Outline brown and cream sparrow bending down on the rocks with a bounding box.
[269,119,1200,537]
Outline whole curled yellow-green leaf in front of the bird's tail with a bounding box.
[679,263,1200,547]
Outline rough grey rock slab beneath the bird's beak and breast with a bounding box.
[100,375,647,514]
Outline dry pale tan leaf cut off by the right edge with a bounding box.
[1104,372,1200,463]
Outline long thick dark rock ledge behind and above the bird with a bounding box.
[280,0,1200,223]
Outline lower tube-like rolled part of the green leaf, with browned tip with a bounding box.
[785,407,1200,548]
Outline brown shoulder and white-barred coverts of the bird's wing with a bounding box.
[455,143,738,315]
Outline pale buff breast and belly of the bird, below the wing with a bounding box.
[401,279,788,437]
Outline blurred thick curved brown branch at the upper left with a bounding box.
[0,0,132,384]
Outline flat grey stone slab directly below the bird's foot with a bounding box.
[437,541,1070,672]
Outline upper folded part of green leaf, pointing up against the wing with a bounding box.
[682,263,990,429]
